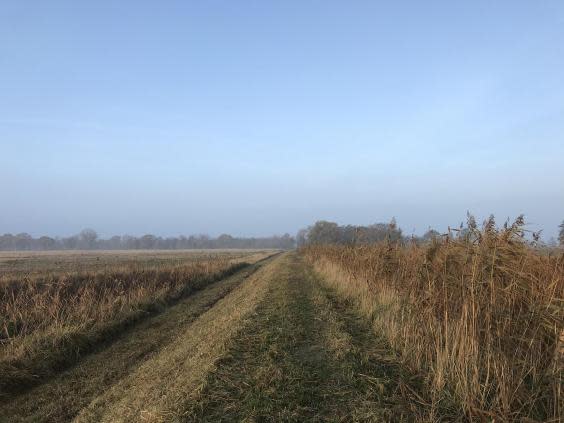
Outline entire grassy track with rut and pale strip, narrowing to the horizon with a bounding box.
[0,253,432,422]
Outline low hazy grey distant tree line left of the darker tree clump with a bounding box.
[0,229,295,251]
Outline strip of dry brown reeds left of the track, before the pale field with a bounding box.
[0,257,246,396]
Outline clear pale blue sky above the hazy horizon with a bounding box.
[0,0,564,237]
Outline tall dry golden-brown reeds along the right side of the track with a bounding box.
[304,220,564,421]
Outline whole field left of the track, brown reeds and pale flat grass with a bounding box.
[0,251,270,396]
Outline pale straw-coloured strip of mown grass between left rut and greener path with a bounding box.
[73,252,284,423]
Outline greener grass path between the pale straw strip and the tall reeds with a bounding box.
[186,254,428,422]
